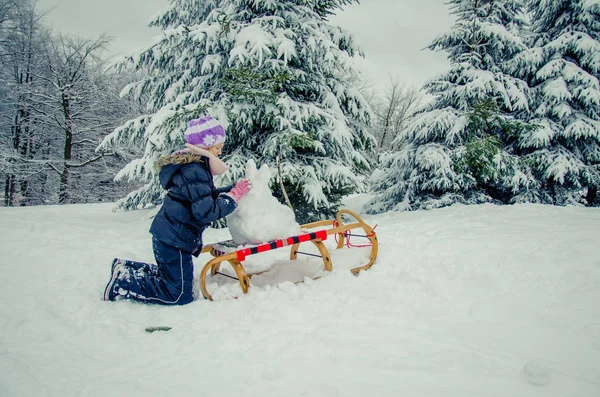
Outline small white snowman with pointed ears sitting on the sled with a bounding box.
[227,160,301,245]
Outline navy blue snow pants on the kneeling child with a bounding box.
[116,238,194,305]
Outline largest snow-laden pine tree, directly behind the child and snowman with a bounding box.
[97,0,374,222]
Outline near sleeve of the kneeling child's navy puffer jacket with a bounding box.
[180,163,237,223]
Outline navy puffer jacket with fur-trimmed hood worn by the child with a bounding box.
[150,154,237,256]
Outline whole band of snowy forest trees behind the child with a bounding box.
[0,0,600,220]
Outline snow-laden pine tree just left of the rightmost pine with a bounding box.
[366,0,534,213]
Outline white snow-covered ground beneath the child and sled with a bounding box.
[0,196,600,397]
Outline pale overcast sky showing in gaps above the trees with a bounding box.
[38,0,454,87]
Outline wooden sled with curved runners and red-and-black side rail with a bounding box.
[200,209,379,300]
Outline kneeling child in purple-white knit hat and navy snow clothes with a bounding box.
[104,116,250,305]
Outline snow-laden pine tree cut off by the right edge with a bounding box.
[512,0,600,205]
